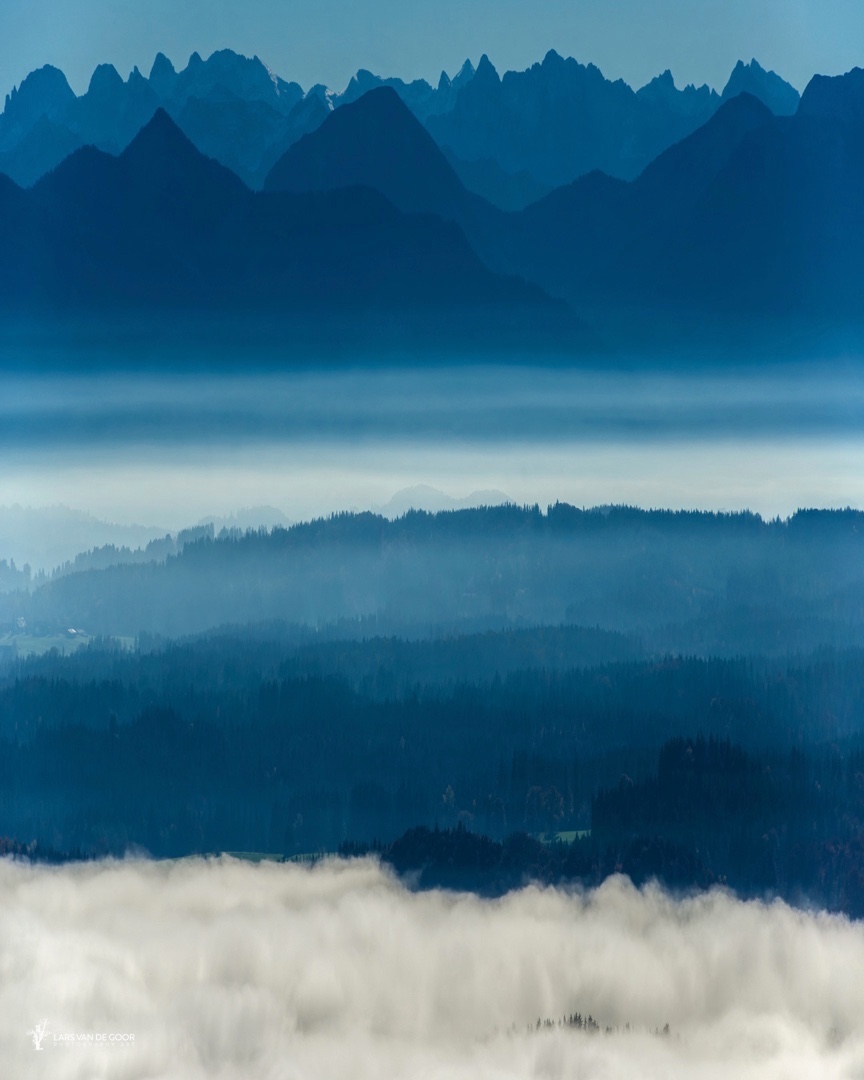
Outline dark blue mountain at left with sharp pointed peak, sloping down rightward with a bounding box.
[0,109,561,347]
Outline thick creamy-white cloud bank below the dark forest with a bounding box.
[0,858,864,1080]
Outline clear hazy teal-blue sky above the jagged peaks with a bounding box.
[0,0,864,93]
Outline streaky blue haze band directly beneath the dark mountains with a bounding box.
[6,365,864,447]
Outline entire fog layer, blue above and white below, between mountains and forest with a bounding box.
[0,365,864,548]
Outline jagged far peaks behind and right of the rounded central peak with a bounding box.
[328,50,798,196]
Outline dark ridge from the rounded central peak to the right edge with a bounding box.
[265,69,864,332]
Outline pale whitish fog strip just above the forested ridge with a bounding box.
[6,436,864,535]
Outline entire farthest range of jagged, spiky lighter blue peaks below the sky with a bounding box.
[0,50,798,210]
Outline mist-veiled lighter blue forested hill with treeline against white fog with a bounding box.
[0,503,864,654]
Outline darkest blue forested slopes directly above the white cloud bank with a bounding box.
[0,633,864,915]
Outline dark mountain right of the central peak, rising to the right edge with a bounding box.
[486,70,864,326]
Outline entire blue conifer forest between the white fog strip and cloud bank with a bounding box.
[0,504,864,915]
